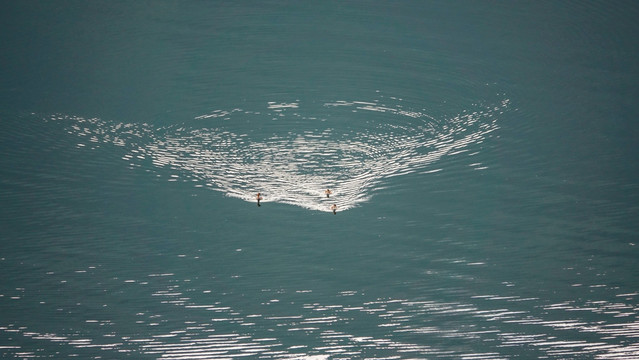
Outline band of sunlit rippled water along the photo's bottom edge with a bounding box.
[0,274,639,359]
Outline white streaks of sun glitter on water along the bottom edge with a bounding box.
[0,278,639,359]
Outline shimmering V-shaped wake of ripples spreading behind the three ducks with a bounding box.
[52,98,509,211]
